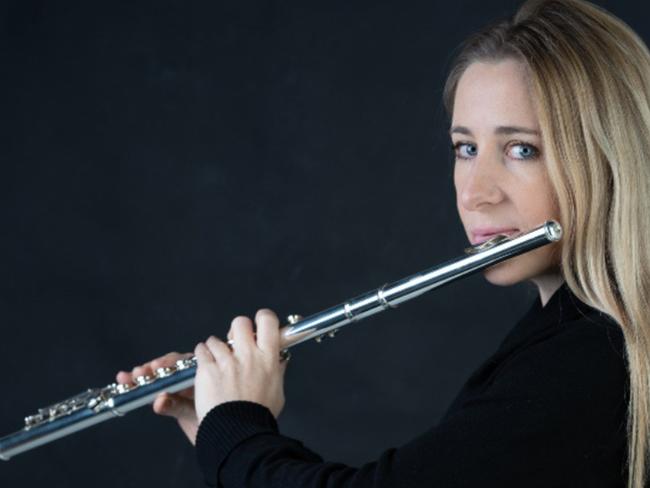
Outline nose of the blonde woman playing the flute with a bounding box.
[457,157,505,210]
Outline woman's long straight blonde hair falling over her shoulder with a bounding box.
[444,0,650,488]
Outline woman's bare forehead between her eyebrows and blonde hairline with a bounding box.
[452,59,539,130]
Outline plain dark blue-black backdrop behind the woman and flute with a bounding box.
[0,0,650,488]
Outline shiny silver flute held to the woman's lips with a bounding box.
[0,221,562,461]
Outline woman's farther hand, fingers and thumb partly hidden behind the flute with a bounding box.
[117,352,199,444]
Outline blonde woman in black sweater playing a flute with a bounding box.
[118,0,650,488]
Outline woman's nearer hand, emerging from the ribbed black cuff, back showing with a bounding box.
[194,309,287,423]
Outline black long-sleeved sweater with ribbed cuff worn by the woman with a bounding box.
[196,285,629,488]
